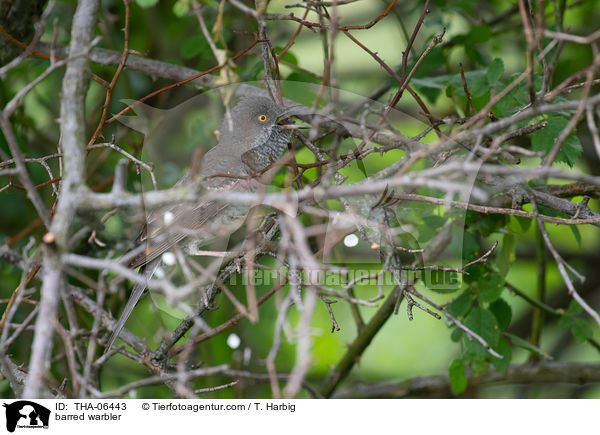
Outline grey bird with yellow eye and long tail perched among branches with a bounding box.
[105,96,296,352]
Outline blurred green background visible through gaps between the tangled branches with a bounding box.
[0,0,600,398]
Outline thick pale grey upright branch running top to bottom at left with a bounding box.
[23,0,99,398]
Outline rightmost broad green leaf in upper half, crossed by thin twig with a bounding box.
[531,116,583,167]
